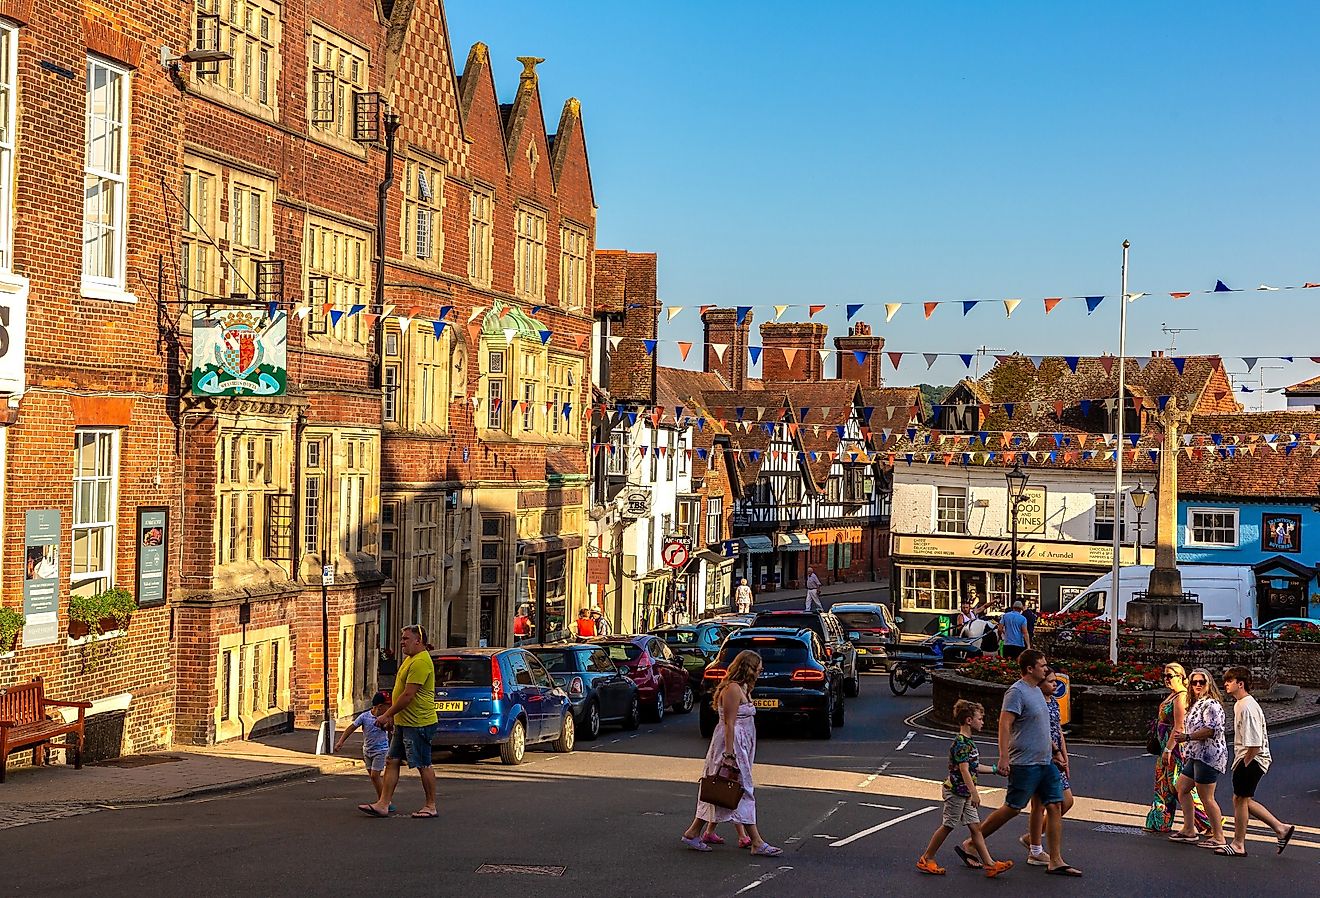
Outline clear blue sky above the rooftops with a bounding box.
[446,0,1320,408]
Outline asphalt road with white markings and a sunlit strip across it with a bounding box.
[0,674,1320,898]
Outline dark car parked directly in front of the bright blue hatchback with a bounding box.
[525,642,642,740]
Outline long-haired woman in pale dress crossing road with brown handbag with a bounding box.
[682,650,784,857]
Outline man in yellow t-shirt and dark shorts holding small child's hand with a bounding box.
[358,623,440,817]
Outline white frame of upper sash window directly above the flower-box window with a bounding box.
[82,55,137,302]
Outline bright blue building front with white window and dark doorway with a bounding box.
[1177,499,1320,623]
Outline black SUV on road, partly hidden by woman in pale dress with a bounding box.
[701,627,843,740]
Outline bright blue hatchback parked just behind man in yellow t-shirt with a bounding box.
[430,648,577,765]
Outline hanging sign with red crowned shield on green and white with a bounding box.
[193,309,289,396]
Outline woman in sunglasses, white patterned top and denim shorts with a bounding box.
[1170,667,1229,848]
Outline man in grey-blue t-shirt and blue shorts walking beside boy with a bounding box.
[953,649,1081,876]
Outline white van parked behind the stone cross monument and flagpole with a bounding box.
[1060,564,1257,627]
